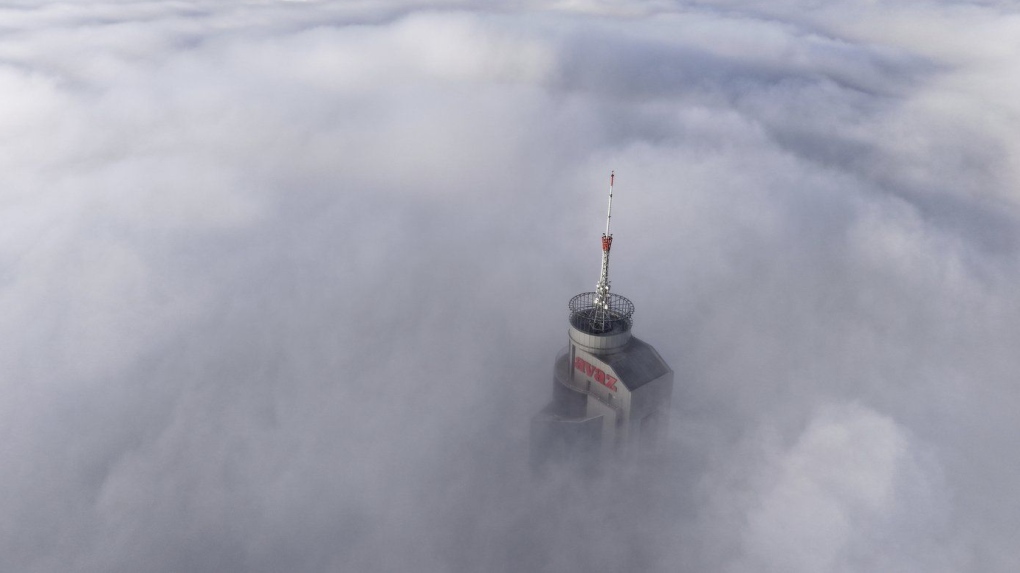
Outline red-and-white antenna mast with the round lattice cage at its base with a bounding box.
[569,171,634,334]
